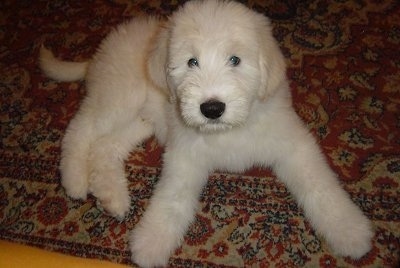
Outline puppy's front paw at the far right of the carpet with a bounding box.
[327,213,374,259]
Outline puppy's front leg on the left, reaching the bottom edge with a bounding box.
[130,149,208,267]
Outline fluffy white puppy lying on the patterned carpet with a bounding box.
[40,0,373,267]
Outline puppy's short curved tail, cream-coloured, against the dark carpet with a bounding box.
[39,45,89,82]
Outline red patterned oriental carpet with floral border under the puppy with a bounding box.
[0,0,400,267]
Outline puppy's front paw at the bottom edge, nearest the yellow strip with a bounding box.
[130,223,181,267]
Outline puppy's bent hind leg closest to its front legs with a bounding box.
[88,118,154,218]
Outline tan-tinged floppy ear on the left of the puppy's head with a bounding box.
[146,22,169,95]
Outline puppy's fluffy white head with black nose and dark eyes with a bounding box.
[149,0,285,132]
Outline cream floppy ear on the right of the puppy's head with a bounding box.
[259,17,286,100]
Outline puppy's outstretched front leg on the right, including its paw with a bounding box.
[274,116,373,259]
